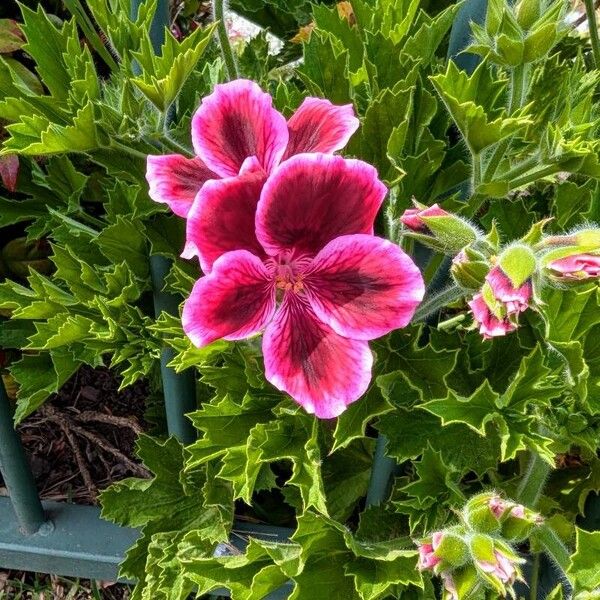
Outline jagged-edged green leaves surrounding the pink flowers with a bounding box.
[0,0,600,600]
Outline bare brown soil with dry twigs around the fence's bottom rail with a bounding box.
[0,366,150,600]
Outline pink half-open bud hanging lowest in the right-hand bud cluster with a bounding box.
[468,267,531,339]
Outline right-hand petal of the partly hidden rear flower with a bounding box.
[283,98,359,160]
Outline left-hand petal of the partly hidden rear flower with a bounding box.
[146,154,219,217]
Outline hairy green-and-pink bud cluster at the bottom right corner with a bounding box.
[418,492,542,600]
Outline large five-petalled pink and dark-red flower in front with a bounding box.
[182,153,424,418]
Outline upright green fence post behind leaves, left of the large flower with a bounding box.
[131,0,197,444]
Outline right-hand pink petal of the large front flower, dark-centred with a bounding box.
[303,234,425,340]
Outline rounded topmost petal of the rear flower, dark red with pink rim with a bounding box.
[192,79,289,177]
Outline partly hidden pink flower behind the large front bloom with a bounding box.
[146,79,359,217]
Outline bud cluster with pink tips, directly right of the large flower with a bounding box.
[400,202,600,339]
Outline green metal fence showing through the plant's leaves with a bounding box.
[0,0,487,600]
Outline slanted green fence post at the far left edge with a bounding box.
[0,377,46,535]
